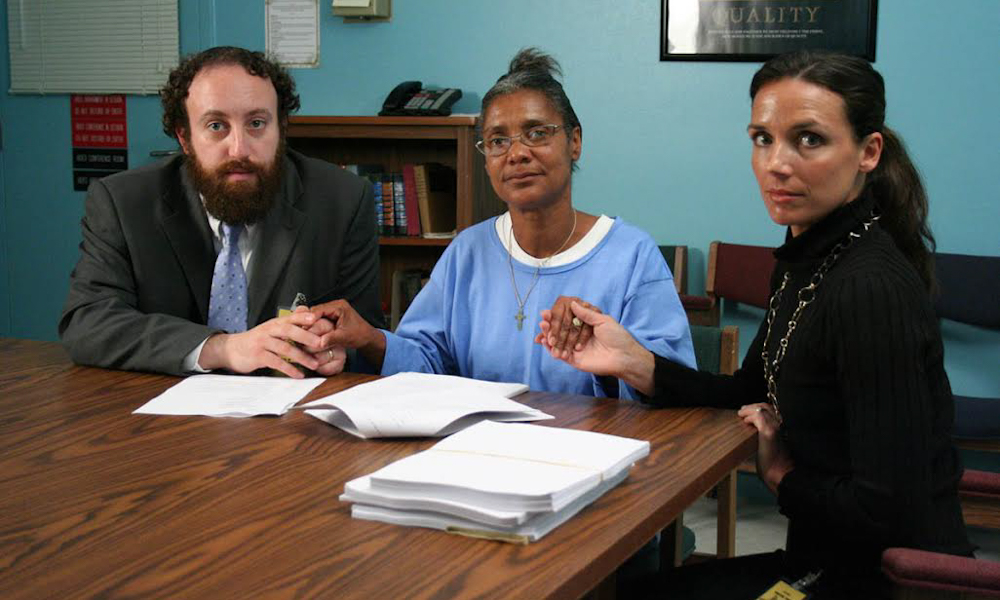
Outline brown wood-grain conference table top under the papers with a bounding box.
[0,339,755,600]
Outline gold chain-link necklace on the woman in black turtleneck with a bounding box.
[760,211,879,422]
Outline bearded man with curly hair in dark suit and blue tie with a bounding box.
[59,47,381,377]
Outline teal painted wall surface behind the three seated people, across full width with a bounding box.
[0,0,1000,395]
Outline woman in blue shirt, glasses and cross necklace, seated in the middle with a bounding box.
[313,49,694,398]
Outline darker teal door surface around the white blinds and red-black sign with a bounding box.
[0,0,212,340]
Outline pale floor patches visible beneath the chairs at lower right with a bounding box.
[684,474,1000,561]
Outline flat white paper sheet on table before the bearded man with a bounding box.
[133,375,326,417]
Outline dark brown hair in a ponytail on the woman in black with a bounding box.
[750,50,935,290]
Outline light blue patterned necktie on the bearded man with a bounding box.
[208,223,247,333]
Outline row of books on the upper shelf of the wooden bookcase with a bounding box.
[343,163,457,237]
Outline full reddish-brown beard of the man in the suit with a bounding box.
[184,136,285,225]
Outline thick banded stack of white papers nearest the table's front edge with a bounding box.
[340,421,649,543]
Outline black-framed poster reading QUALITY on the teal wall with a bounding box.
[660,0,878,62]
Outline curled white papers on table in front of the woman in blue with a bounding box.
[295,373,552,438]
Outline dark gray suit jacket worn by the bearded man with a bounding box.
[59,150,382,374]
